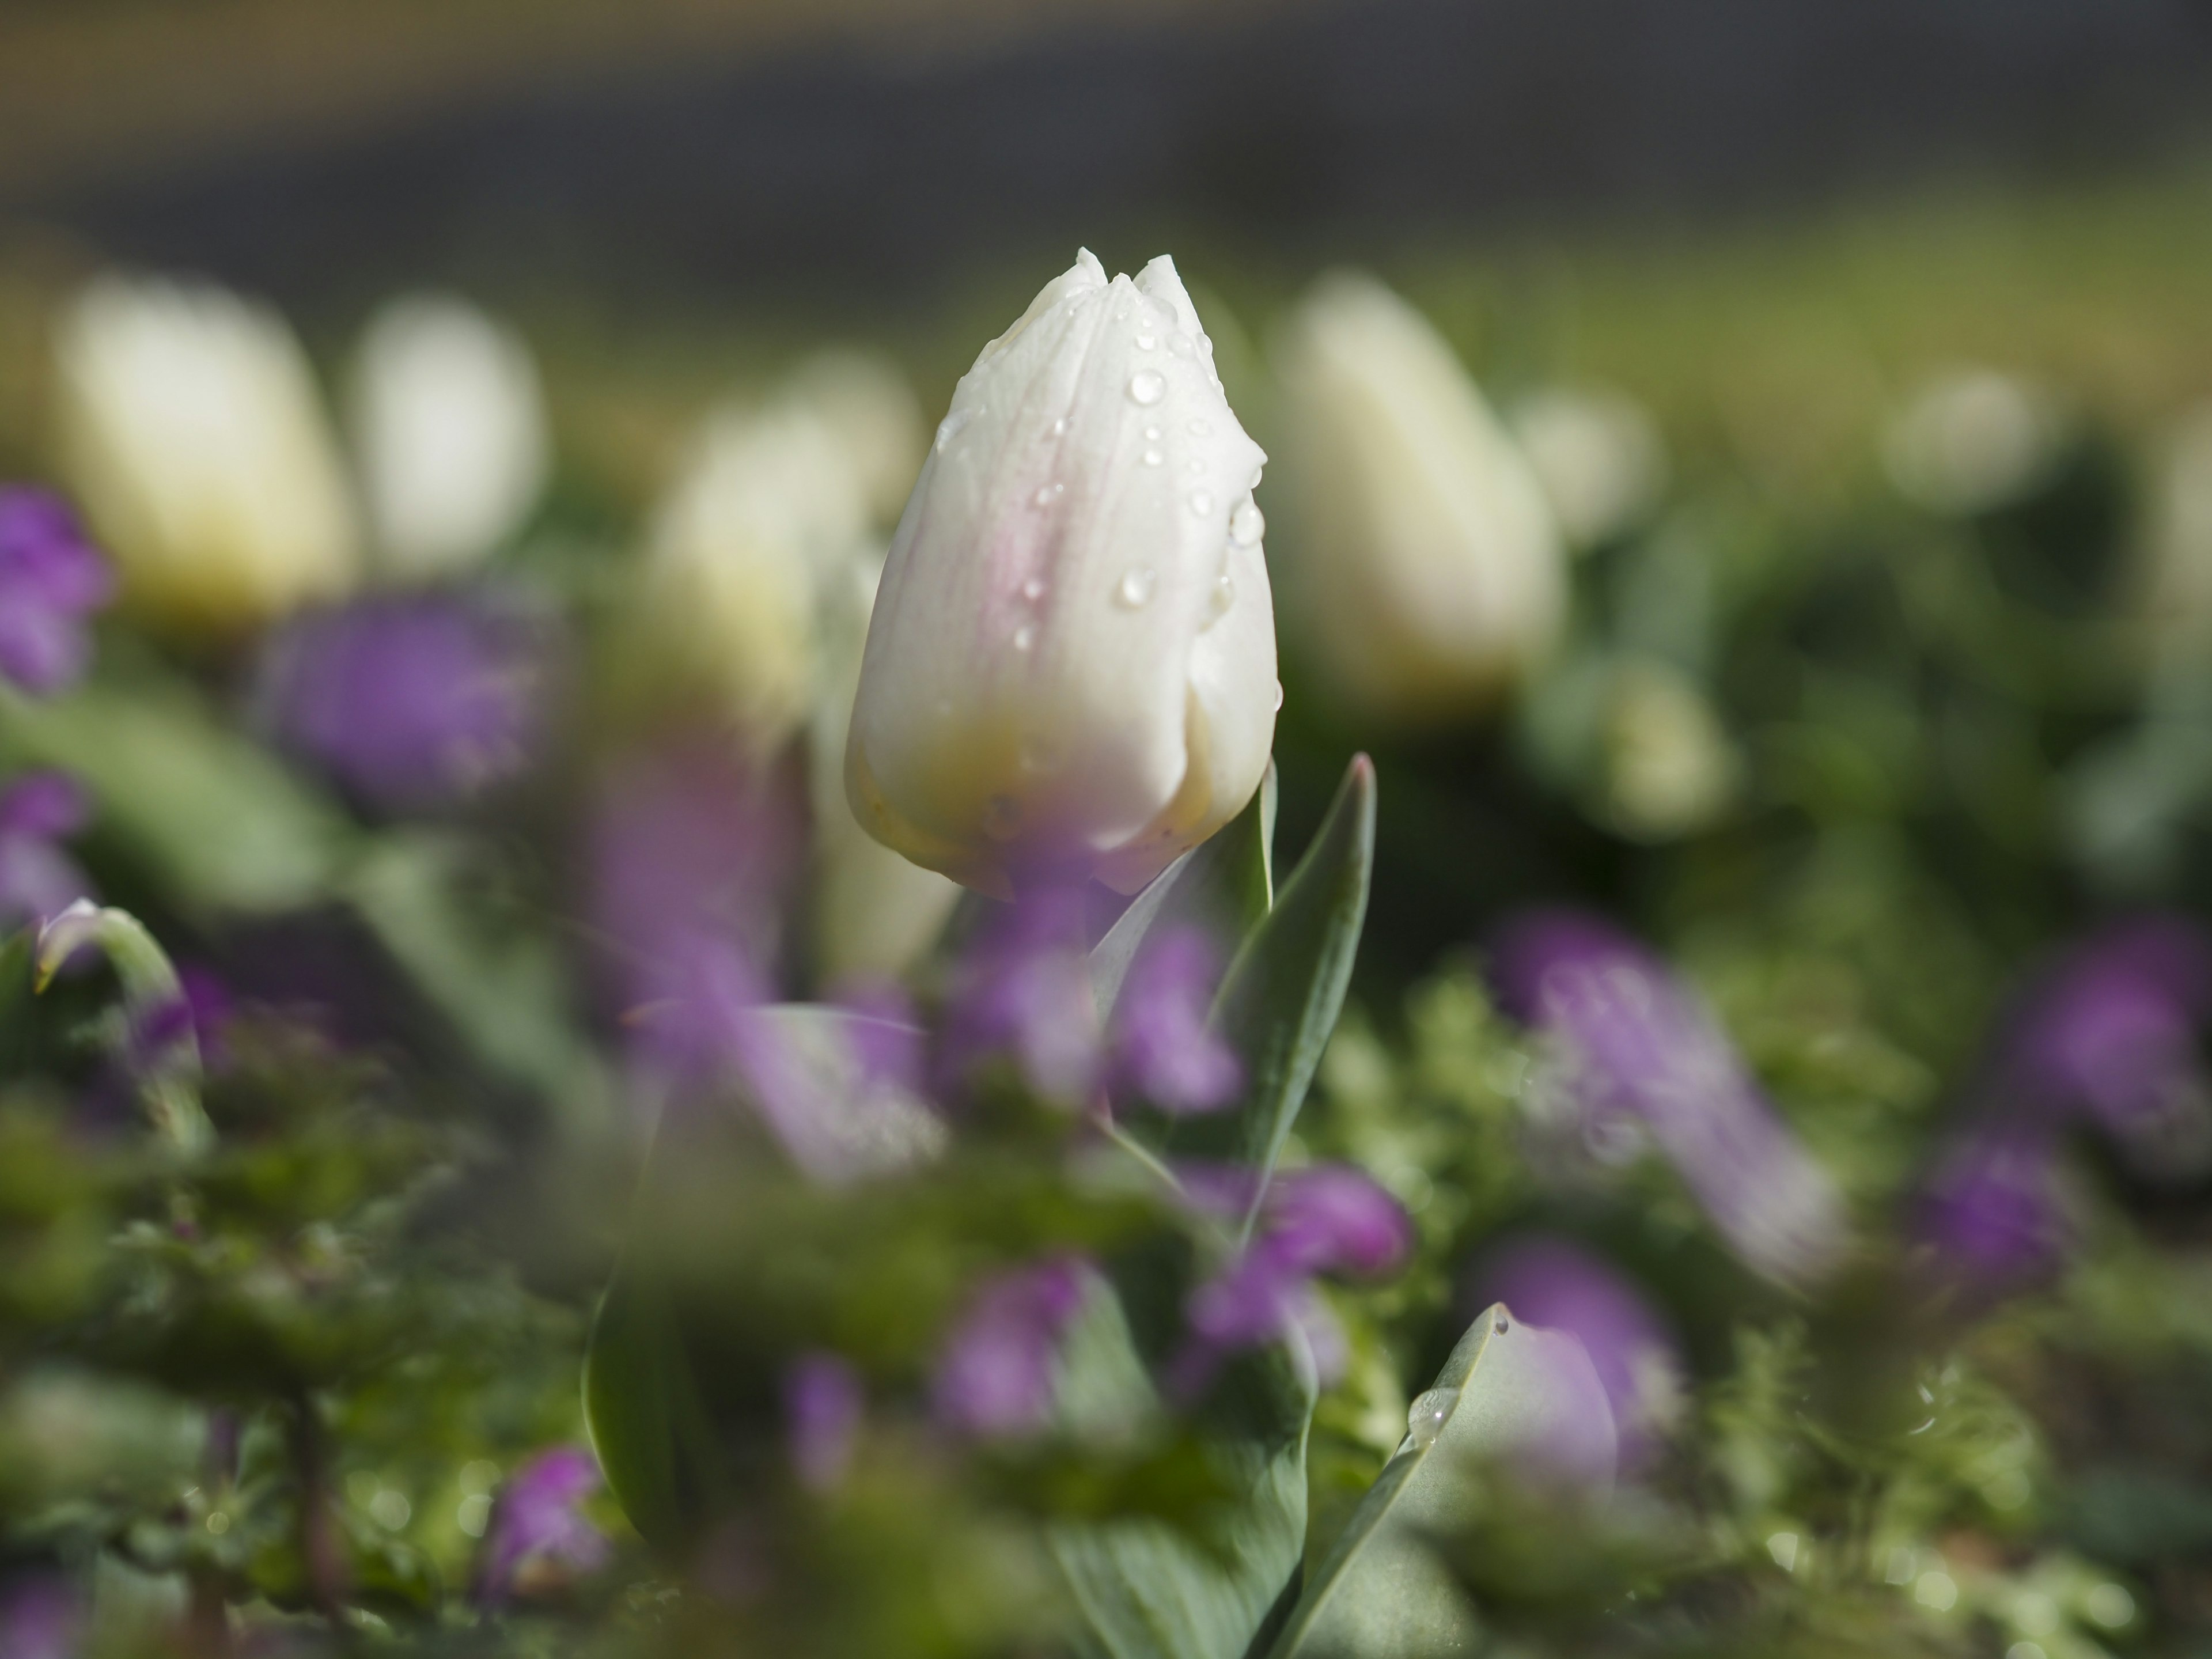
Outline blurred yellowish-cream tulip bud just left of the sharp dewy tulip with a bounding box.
[639,403,867,750]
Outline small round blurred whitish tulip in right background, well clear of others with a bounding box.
[1883,369,2066,516]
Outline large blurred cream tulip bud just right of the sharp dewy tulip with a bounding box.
[1281,274,1566,721]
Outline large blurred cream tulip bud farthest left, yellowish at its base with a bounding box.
[55,276,358,635]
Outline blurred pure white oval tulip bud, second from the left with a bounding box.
[352,294,548,582]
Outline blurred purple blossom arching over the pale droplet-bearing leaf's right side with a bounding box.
[1462,1234,1681,1469]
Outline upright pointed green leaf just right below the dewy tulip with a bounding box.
[1161,754,1376,1232]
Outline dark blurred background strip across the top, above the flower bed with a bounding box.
[13,0,2212,297]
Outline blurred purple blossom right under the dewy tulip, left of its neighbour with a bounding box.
[940,887,1101,1106]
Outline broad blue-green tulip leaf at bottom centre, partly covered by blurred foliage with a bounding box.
[1051,1283,1316,1659]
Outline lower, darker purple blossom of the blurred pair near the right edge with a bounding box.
[1914,1124,2075,1298]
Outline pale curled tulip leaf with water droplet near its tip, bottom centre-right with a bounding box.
[1272,1303,1617,1659]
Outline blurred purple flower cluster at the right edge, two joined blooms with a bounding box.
[1915,916,2212,1296]
